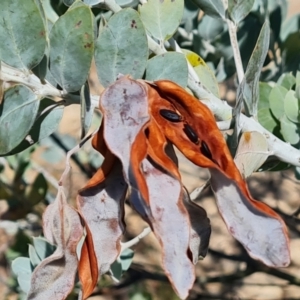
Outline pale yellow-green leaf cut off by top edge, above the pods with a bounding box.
[139,0,184,41]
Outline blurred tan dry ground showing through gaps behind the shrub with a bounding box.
[0,0,300,300]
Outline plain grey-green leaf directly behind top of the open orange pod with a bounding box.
[146,52,188,87]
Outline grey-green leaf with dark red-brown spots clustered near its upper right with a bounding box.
[95,8,148,87]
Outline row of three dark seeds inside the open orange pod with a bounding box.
[159,109,212,160]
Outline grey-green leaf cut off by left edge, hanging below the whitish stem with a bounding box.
[0,85,39,155]
